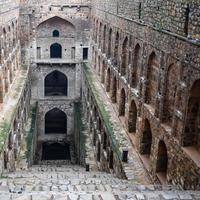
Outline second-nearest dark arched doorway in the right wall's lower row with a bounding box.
[140,119,152,157]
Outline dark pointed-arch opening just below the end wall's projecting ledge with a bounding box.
[44,70,68,96]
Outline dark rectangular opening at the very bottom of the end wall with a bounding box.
[42,143,71,160]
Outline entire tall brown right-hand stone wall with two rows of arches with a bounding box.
[91,1,200,189]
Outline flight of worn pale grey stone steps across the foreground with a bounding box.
[0,163,200,200]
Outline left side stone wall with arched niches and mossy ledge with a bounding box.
[0,1,30,173]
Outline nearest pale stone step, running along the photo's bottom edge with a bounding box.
[0,191,200,200]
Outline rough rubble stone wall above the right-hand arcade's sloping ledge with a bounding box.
[92,0,199,39]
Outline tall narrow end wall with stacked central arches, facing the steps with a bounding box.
[20,1,90,162]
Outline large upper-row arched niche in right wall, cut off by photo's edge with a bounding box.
[183,79,200,152]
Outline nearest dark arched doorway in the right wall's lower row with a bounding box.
[156,141,168,181]
